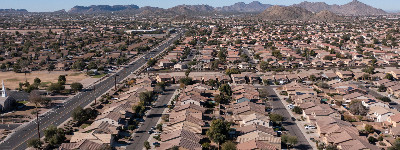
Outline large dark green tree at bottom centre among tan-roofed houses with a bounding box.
[206,119,231,147]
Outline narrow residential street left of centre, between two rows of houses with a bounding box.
[126,86,179,150]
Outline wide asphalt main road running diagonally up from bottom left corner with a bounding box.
[0,29,182,150]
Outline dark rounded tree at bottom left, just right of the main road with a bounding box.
[44,125,66,146]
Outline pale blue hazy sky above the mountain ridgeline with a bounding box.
[0,0,400,12]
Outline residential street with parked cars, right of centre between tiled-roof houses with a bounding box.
[258,86,312,150]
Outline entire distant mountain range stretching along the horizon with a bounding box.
[0,0,387,16]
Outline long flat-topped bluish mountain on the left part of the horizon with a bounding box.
[68,5,139,13]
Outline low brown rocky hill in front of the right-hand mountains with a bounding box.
[259,6,343,22]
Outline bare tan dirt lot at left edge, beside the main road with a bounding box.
[0,71,88,90]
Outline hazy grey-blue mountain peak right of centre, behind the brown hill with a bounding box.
[217,1,272,12]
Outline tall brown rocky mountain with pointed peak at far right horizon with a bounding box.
[292,0,387,16]
